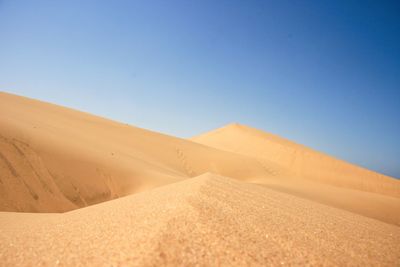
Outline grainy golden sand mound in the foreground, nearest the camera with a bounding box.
[0,174,400,266]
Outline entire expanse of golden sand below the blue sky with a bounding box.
[0,93,400,266]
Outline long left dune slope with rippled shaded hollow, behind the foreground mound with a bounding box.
[0,93,269,212]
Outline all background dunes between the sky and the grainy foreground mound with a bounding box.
[0,93,400,225]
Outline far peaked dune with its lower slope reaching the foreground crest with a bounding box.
[191,123,400,225]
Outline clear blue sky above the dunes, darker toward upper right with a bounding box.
[0,0,400,177]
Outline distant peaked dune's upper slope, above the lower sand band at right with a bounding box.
[191,123,400,197]
